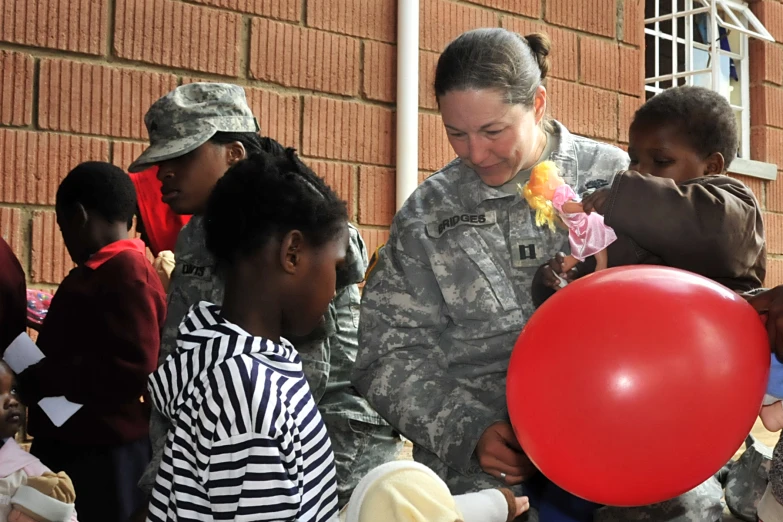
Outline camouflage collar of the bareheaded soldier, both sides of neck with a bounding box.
[454,120,579,210]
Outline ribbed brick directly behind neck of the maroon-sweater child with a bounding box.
[30,211,75,284]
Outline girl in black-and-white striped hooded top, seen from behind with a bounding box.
[148,149,348,522]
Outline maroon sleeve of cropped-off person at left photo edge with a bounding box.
[0,238,27,353]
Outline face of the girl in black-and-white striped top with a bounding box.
[284,224,349,336]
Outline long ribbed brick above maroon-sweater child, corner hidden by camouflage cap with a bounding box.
[38,59,177,140]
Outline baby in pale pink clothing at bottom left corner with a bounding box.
[0,361,76,522]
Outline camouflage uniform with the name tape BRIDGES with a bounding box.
[353,122,720,522]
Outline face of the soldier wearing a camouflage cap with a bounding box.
[158,141,236,215]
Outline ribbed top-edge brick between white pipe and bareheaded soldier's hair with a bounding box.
[419,0,498,53]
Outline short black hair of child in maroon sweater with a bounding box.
[56,161,136,230]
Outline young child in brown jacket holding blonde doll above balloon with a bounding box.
[542,87,766,292]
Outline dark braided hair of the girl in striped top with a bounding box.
[204,148,348,264]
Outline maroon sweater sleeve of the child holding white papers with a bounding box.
[24,260,165,405]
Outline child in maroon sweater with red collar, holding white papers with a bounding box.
[19,162,166,522]
